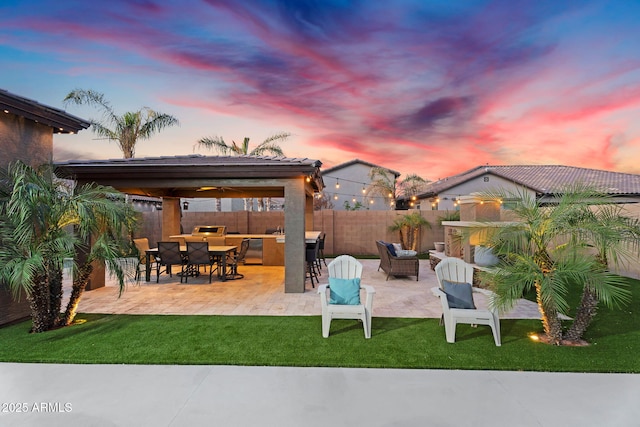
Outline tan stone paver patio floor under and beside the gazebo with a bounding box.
[65,259,539,319]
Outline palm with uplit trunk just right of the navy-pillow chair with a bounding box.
[482,184,630,345]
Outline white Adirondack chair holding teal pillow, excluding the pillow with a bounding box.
[318,255,376,338]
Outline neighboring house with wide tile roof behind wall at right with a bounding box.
[398,165,640,210]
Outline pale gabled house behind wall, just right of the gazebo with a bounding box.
[322,159,400,210]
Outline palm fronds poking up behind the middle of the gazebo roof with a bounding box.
[194,132,291,211]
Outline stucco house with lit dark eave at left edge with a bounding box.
[0,89,90,325]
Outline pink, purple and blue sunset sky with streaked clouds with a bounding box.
[0,0,640,180]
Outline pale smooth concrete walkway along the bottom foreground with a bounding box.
[0,363,640,427]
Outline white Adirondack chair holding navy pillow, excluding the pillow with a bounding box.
[431,258,501,346]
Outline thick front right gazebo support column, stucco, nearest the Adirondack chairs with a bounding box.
[284,177,306,293]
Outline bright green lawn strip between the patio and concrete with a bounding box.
[0,280,640,372]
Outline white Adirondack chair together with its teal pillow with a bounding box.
[318,255,376,338]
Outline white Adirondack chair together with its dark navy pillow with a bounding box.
[431,258,501,346]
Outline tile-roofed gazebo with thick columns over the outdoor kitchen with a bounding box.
[56,154,324,293]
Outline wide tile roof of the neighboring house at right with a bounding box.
[420,165,640,197]
